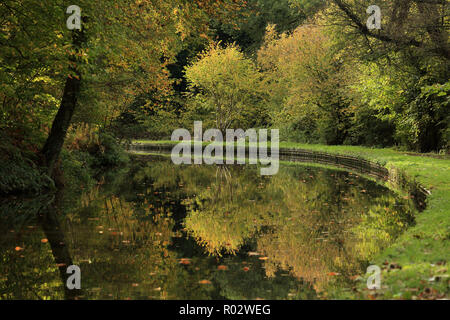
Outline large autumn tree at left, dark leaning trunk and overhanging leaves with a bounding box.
[0,0,251,172]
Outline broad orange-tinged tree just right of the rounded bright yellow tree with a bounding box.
[258,26,351,144]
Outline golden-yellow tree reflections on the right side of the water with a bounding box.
[179,167,412,290]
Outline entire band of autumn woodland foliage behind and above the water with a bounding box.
[0,0,450,192]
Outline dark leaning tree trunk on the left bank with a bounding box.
[41,30,86,175]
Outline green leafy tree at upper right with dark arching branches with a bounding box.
[326,0,450,152]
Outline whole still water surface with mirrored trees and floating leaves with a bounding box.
[0,159,413,299]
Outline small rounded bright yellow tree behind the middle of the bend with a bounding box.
[186,43,261,131]
